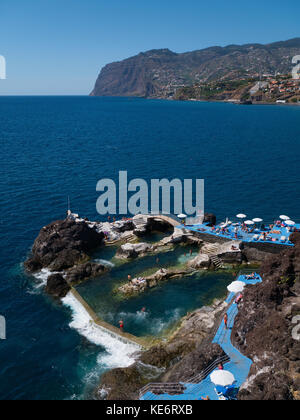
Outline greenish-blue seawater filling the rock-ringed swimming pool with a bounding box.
[76,246,234,337]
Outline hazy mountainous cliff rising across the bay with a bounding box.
[91,38,300,98]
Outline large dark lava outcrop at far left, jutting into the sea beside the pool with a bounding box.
[25,219,104,272]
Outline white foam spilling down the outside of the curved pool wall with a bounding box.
[62,293,139,369]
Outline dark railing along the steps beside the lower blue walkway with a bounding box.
[139,355,230,399]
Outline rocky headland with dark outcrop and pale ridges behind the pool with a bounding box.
[24,212,276,298]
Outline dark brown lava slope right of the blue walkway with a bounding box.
[232,234,300,400]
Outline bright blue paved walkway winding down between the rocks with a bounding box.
[141,274,262,401]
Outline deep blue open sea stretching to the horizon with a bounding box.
[0,97,300,399]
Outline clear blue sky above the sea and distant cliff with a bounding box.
[0,0,300,95]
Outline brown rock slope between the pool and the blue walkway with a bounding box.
[95,300,227,400]
